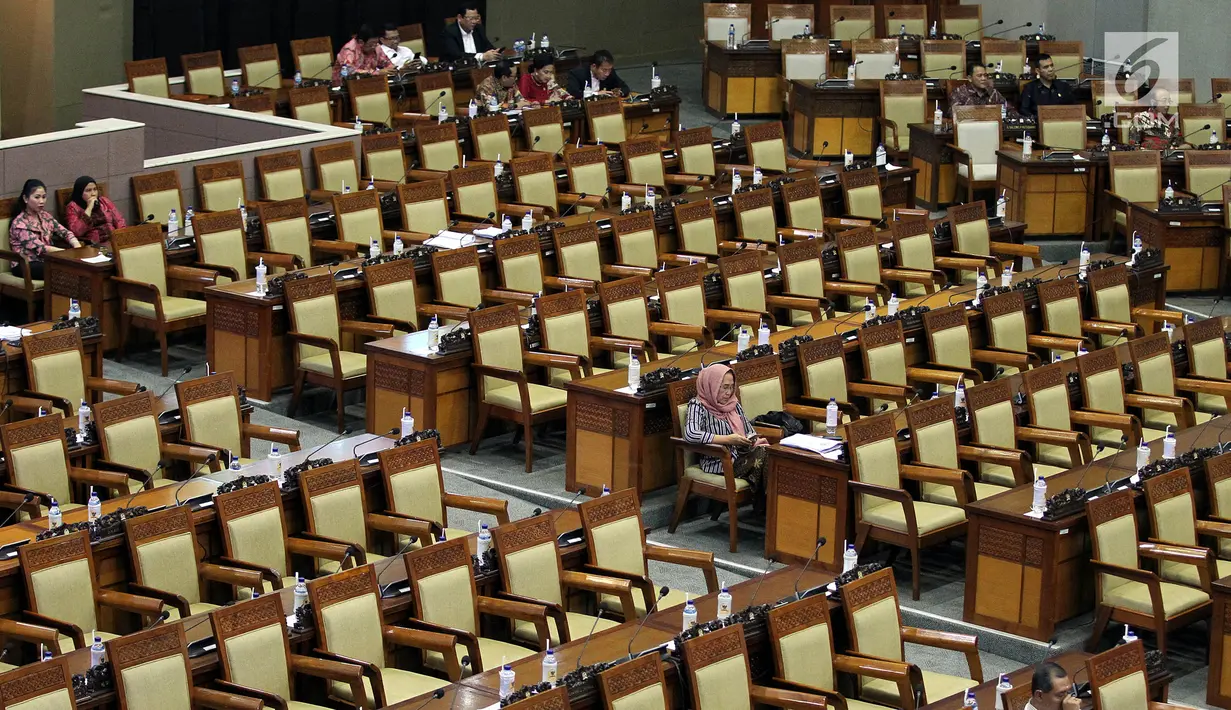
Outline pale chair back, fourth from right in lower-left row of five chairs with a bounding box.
[124,506,201,604]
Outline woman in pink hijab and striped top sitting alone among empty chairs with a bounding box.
[684,364,769,489]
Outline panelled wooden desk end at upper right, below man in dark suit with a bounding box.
[997,148,1098,239]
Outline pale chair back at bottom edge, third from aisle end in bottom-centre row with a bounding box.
[682,624,752,710]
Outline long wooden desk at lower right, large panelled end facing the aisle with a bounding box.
[963,413,1231,641]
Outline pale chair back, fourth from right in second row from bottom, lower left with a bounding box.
[308,565,385,668]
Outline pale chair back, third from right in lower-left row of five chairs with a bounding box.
[214,481,291,577]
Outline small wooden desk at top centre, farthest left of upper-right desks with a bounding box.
[700,42,782,117]
